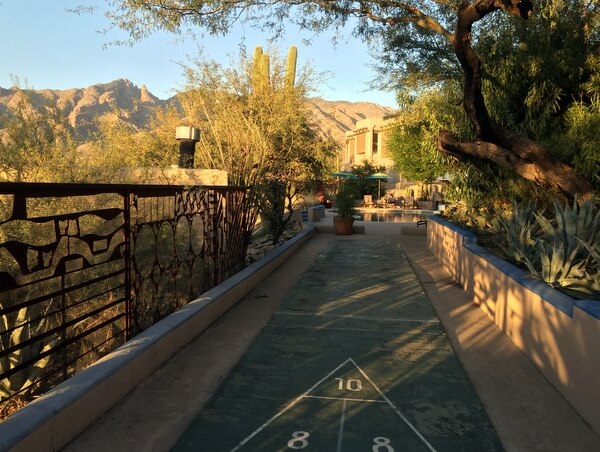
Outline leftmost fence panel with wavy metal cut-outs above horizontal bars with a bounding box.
[0,187,126,418]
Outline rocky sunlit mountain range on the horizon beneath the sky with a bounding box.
[0,79,394,146]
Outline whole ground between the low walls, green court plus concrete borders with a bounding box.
[66,223,600,451]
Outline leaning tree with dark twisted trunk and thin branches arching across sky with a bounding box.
[102,0,598,197]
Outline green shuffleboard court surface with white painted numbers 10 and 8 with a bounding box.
[174,239,502,452]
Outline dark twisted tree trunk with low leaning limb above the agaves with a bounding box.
[438,0,595,199]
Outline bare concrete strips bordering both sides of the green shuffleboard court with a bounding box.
[67,223,600,451]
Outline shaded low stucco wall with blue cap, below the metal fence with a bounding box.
[0,226,315,452]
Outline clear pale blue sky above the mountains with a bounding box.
[0,0,396,107]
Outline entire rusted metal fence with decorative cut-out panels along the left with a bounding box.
[0,183,247,419]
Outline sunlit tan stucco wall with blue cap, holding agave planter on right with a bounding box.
[427,216,600,433]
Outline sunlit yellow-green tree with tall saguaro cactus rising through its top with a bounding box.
[179,47,335,242]
